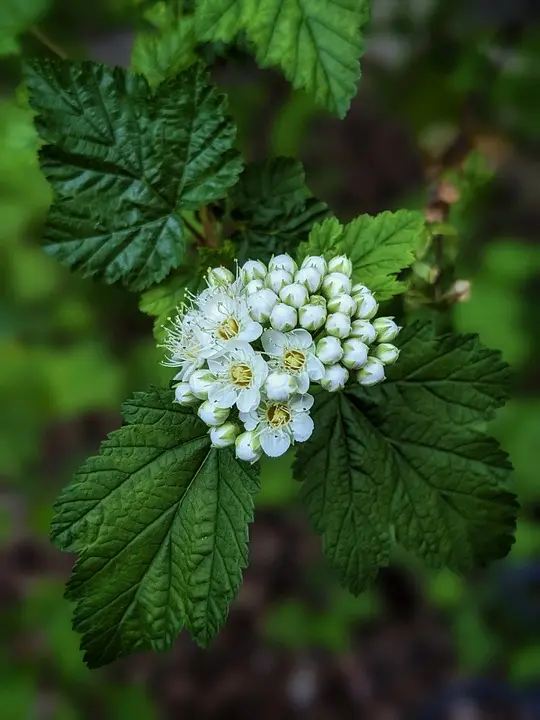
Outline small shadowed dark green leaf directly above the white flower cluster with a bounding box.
[230,157,327,262]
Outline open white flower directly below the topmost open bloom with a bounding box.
[208,343,268,412]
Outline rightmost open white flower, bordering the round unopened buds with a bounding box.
[261,330,324,393]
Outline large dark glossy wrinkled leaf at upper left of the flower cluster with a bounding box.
[27,60,242,290]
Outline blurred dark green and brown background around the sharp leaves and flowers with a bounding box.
[0,0,540,720]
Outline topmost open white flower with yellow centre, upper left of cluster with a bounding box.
[194,290,265,359]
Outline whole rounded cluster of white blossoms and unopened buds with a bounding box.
[160,255,400,462]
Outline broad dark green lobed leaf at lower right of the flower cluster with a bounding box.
[295,325,518,593]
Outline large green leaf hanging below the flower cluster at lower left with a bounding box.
[52,389,259,667]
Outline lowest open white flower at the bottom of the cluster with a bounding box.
[240,394,314,457]
